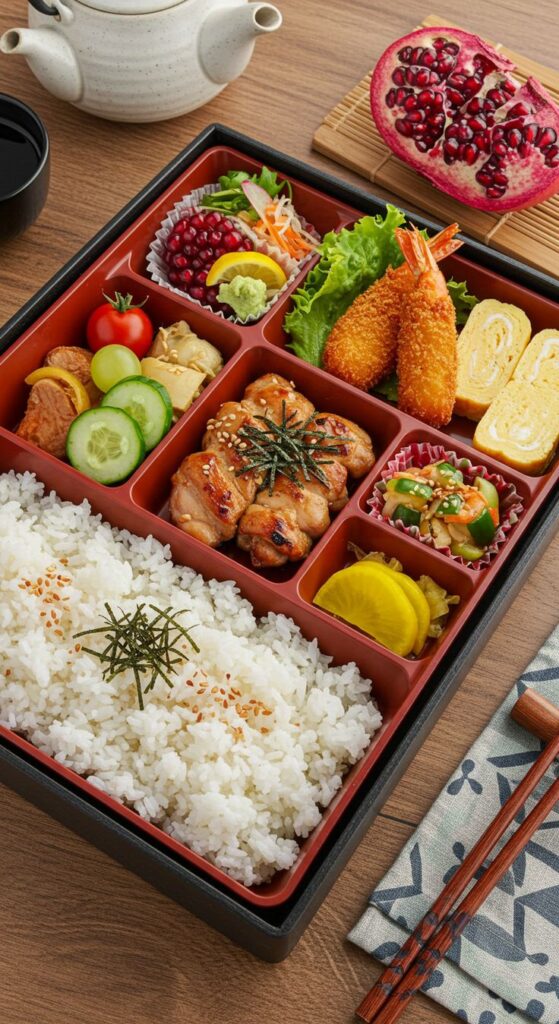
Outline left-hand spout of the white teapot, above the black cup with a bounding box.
[0,29,83,103]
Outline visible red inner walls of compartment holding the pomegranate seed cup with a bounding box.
[127,146,353,273]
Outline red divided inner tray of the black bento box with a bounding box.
[0,140,559,907]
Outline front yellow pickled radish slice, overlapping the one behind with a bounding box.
[314,561,419,657]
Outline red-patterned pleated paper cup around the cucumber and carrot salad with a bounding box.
[368,441,524,569]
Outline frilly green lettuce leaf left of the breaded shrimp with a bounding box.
[285,205,405,367]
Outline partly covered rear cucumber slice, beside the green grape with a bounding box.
[101,376,173,452]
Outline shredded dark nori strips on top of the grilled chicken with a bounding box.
[237,401,340,495]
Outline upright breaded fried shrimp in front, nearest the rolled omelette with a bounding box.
[396,229,458,427]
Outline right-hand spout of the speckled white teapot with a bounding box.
[199,2,283,85]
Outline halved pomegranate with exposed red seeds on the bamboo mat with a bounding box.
[371,28,559,213]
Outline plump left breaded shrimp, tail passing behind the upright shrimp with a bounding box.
[323,224,462,391]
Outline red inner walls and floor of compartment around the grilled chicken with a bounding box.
[127,345,391,582]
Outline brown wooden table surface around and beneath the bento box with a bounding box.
[0,0,559,1024]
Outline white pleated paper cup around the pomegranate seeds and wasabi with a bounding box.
[147,183,320,326]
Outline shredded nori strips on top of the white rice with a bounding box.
[74,601,200,711]
